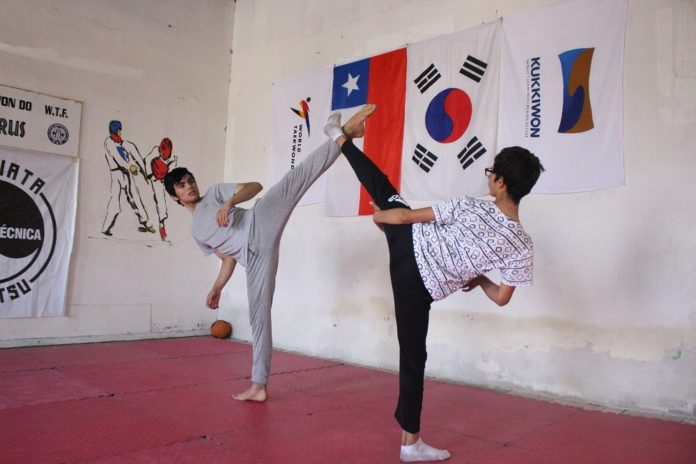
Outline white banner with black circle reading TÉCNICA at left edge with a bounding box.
[0,148,79,318]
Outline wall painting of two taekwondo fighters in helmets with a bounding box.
[102,120,177,241]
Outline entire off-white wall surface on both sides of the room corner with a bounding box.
[0,0,696,419]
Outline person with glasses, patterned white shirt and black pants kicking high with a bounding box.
[324,105,544,462]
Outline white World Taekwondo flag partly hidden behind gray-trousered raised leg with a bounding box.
[269,68,332,206]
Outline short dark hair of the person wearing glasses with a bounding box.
[493,147,544,204]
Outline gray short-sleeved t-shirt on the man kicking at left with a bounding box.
[191,184,252,267]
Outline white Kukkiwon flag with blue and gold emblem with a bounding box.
[499,0,626,193]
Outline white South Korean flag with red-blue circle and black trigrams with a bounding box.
[401,20,501,201]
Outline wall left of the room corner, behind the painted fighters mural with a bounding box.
[0,0,234,346]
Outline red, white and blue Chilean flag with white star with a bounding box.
[326,48,406,216]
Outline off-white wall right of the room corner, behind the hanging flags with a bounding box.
[220,0,696,419]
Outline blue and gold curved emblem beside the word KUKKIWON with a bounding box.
[558,48,594,134]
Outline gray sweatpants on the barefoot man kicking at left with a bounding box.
[246,140,341,385]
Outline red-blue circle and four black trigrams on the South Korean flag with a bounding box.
[411,55,488,173]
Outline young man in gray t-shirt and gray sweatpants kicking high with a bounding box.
[164,107,374,402]
